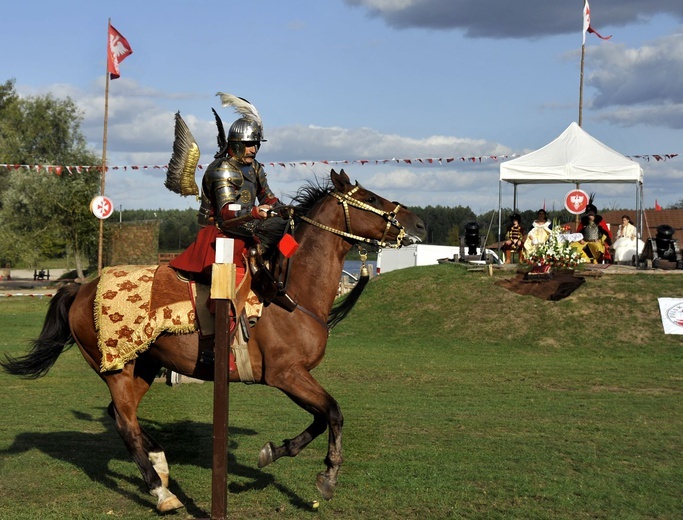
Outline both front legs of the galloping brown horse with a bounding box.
[259,368,344,500]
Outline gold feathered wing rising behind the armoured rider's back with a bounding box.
[164,112,200,200]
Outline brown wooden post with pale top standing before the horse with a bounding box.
[211,238,235,520]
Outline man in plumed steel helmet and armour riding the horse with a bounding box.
[170,94,279,284]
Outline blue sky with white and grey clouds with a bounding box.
[0,0,683,214]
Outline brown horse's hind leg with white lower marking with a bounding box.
[104,363,183,512]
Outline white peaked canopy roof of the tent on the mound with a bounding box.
[500,123,643,184]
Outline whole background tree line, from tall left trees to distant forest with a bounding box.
[0,80,683,277]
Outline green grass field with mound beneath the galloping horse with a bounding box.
[0,265,683,520]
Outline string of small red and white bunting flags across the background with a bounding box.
[0,153,678,175]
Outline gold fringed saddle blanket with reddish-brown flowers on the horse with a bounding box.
[94,265,260,381]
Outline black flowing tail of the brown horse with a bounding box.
[0,283,80,379]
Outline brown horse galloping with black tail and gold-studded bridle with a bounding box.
[2,170,425,512]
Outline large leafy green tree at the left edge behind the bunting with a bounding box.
[0,80,99,276]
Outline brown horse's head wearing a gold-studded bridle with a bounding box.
[330,170,426,247]
